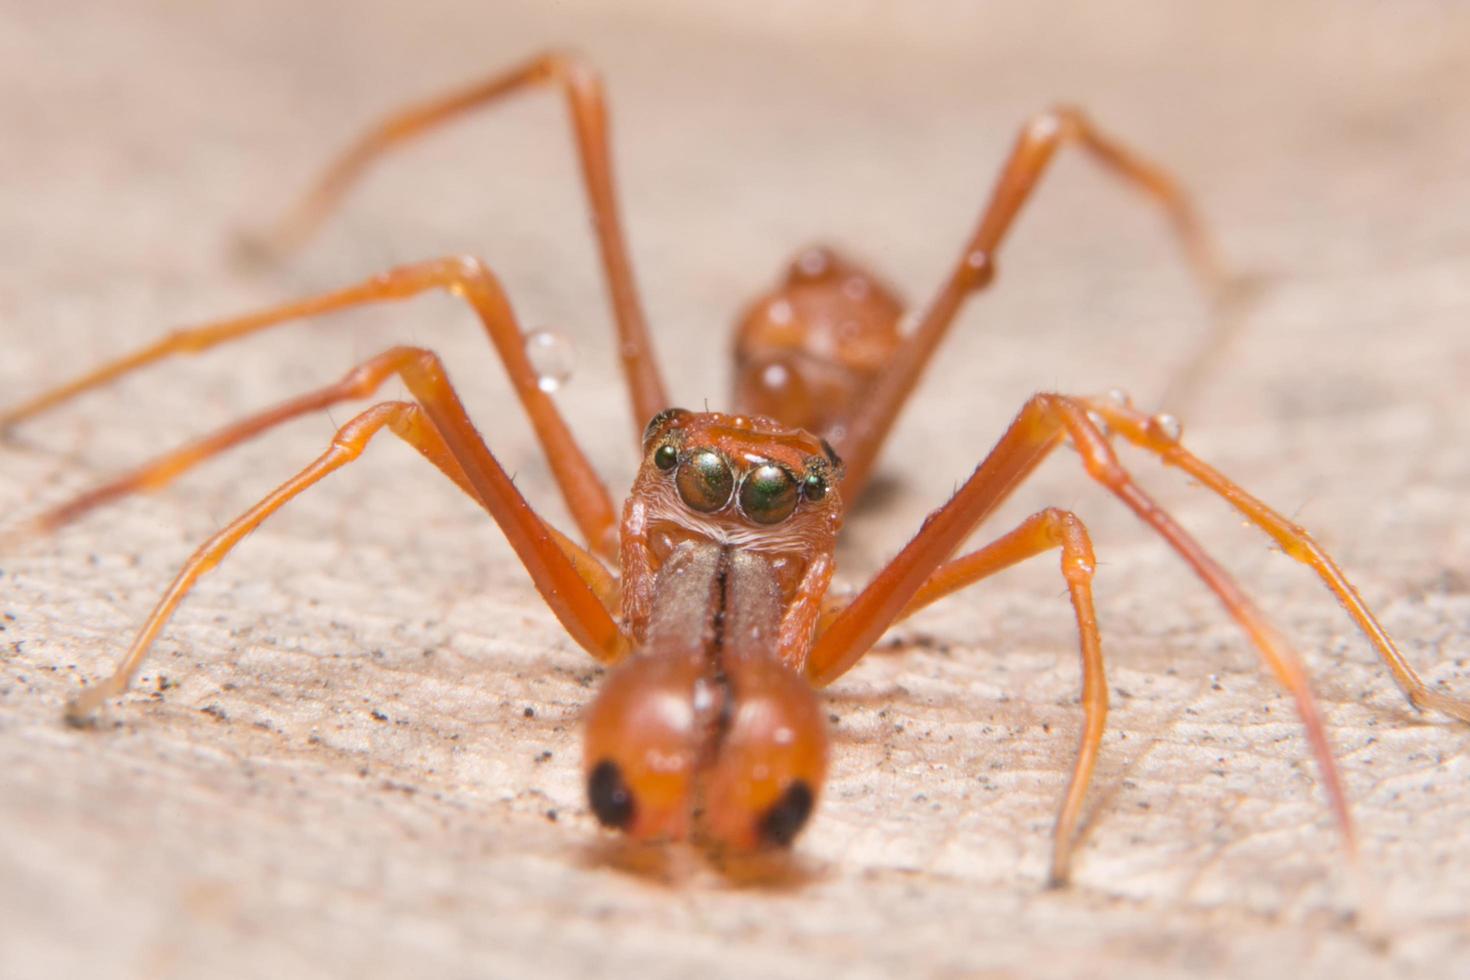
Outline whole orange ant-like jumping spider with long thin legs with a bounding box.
[0,53,1470,884]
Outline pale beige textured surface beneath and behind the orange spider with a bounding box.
[0,0,1470,980]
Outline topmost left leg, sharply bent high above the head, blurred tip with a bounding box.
[245,53,669,433]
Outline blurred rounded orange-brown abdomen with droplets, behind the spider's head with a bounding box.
[735,247,903,439]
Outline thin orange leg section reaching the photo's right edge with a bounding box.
[1082,398,1470,721]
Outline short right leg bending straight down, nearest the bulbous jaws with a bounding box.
[870,507,1107,884]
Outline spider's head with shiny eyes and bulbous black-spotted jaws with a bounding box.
[585,408,841,849]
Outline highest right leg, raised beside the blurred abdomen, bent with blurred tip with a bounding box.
[836,107,1226,500]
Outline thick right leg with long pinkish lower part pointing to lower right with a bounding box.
[806,394,1357,875]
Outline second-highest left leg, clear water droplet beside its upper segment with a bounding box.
[0,259,617,557]
